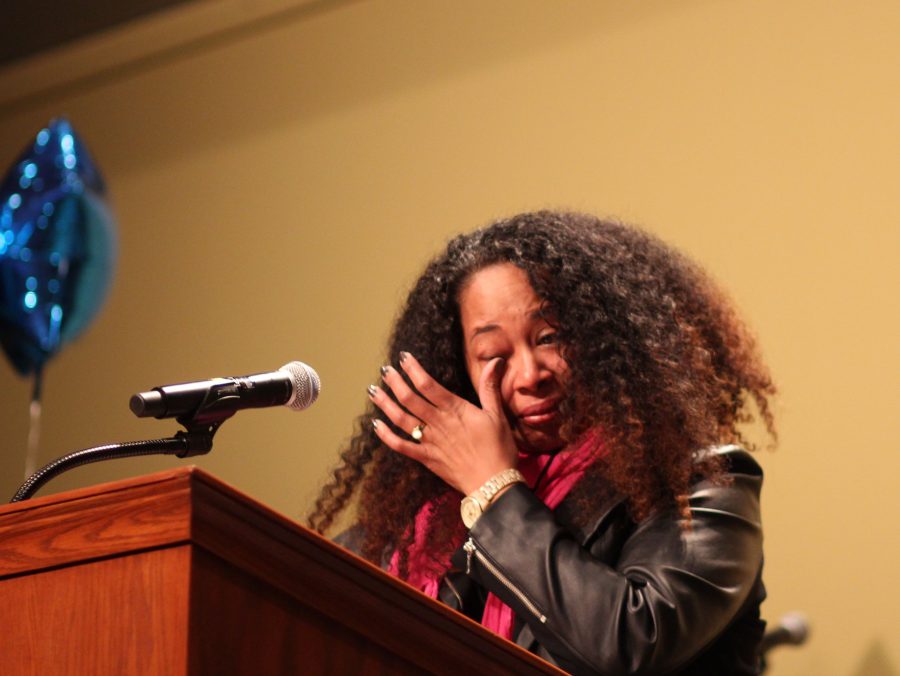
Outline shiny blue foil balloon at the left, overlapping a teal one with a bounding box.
[0,119,116,375]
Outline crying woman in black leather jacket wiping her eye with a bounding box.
[310,212,775,674]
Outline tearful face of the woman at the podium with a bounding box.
[459,263,569,453]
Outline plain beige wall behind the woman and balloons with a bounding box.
[0,0,900,676]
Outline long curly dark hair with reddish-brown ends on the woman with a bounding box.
[309,211,776,575]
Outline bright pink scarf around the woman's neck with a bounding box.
[388,432,605,638]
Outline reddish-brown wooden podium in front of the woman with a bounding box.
[0,467,563,676]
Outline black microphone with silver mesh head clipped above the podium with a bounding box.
[129,361,321,419]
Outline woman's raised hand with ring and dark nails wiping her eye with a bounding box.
[369,352,518,494]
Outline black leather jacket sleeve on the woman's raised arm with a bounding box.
[467,451,762,676]
